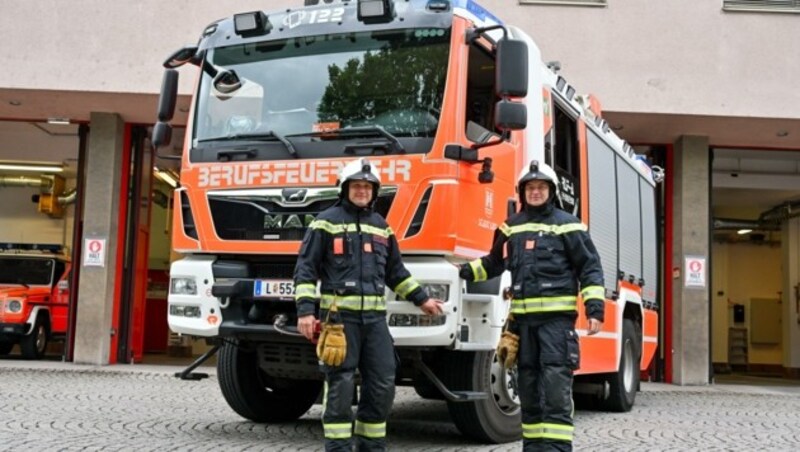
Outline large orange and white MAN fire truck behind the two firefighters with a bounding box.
[153,0,661,443]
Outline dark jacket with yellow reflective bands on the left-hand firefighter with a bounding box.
[294,200,428,321]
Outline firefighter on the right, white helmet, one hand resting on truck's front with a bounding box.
[459,161,605,451]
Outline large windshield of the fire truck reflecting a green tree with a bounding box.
[192,29,450,161]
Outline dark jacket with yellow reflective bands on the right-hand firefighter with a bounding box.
[460,200,605,321]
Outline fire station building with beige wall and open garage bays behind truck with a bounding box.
[0,0,800,385]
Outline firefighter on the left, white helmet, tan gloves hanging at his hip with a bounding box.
[294,159,442,451]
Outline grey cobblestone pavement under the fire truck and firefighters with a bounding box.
[0,359,800,451]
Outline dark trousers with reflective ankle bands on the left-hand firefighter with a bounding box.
[322,321,396,451]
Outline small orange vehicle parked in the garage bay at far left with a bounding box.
[0,243,71,359]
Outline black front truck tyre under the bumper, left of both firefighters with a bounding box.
[217,340,322,422]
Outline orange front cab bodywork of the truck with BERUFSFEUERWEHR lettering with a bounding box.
[173,18,524,257]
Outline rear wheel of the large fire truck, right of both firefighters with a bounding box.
[600,319,642,412]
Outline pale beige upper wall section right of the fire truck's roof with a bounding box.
[482,0,800,118]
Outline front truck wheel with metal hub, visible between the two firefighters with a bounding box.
[442,351,522,444]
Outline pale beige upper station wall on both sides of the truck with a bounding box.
[0,0,800,118]
